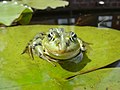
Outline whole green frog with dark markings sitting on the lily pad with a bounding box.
[22,28,86,66]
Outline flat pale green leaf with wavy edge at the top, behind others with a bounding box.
[22,0,69,9]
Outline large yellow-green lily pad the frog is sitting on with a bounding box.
[0,25,120,90]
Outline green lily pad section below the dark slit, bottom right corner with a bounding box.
[62,68,120,90]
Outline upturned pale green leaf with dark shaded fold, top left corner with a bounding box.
[0,1,32,26]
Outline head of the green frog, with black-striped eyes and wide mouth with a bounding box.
[42,28,81,60]
